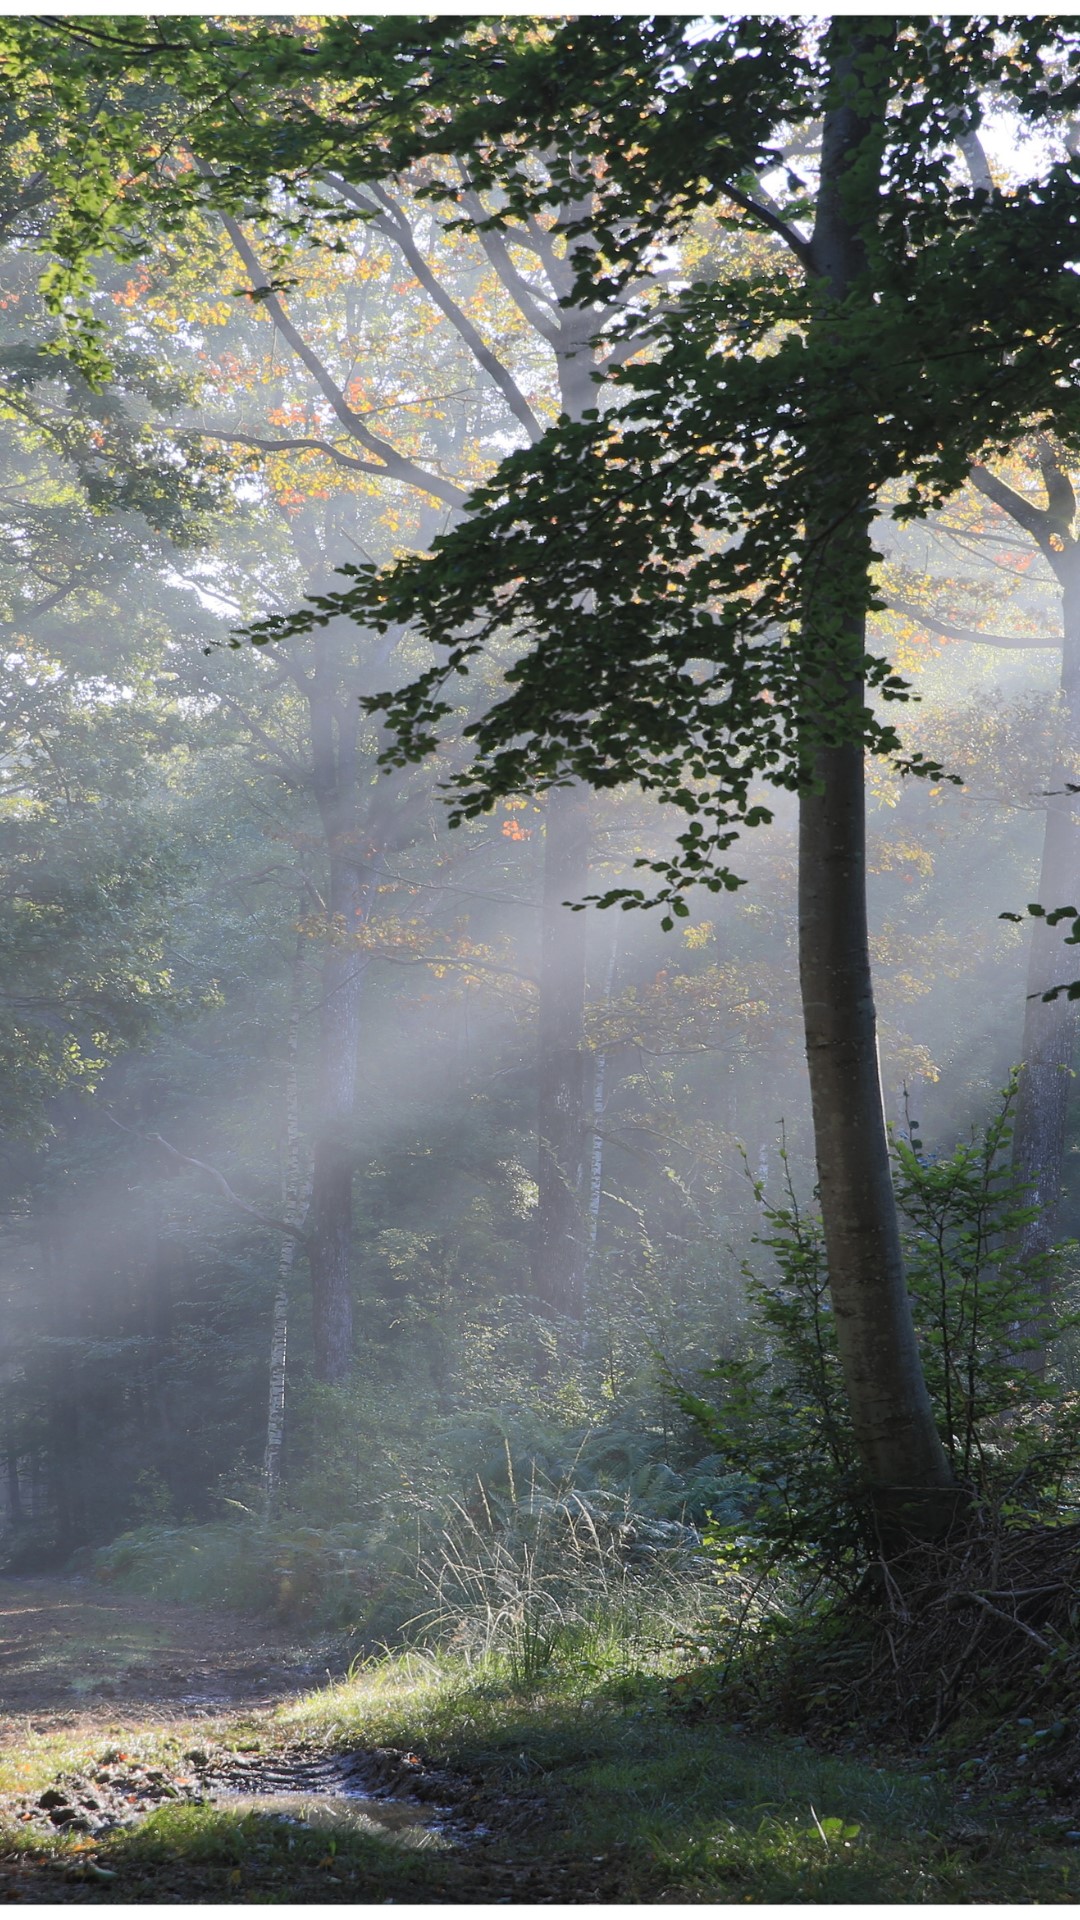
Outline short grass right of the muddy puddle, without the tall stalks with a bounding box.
[276,1657,1080,1903]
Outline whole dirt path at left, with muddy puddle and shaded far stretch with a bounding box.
[0,1578,617,1905]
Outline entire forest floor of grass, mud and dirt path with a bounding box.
[0,1578,1080,1905]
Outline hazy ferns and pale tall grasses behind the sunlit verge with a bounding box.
[86,1409,746,1651]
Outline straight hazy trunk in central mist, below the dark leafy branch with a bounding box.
[532,785,590,1319]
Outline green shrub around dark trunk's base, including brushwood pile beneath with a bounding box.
[661,1081,1080,1759]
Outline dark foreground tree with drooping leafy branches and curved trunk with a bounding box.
[235,19,1076,1530]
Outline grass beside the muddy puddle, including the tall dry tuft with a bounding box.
[0,1488,1080,1905]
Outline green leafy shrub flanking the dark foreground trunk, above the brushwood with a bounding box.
[673,1081,1080,1596]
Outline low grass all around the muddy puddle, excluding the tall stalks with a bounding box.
[0,1653,1080,1905]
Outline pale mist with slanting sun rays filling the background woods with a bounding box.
[0,3,1080,1651]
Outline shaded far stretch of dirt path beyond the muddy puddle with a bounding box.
[0,1578,344,1745]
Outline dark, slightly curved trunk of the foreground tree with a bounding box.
[799,17,955,1536]
